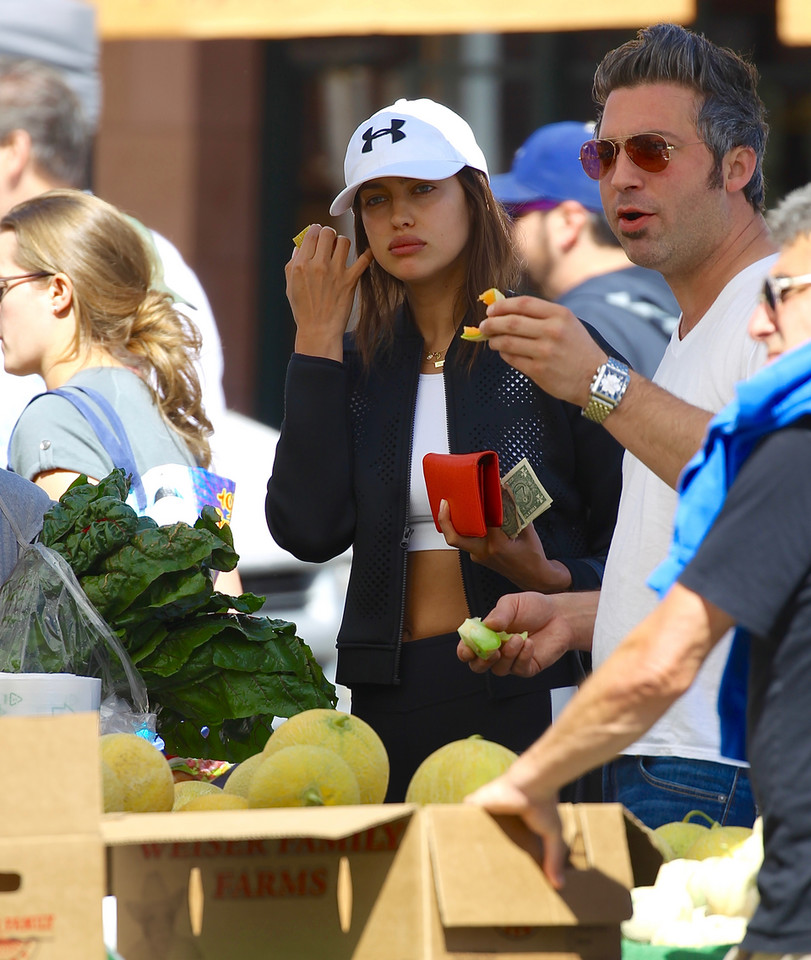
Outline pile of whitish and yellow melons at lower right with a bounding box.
[622,811,763,948]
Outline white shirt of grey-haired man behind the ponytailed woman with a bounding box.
[0,230,225,469]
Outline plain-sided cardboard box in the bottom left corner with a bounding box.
[0,713,107,960]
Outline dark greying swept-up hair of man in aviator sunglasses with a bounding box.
[593,23,769,212]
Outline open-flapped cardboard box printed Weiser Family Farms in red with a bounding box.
[102,804,660,960]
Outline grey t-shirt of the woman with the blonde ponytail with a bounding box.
[9,367,196,488]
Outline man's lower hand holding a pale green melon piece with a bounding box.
[456,593,591,677]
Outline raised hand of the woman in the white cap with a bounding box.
[284,223,373,360]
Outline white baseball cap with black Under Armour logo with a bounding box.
[329,100,487,217]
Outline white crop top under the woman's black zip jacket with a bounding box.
[408,373,456,552]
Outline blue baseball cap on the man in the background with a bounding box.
[490,120,603,213]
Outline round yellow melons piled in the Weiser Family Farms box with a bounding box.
[101,709,516,813]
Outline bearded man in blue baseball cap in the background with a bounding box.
[491,121,680,377]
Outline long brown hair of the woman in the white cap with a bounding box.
[353,167,520,365]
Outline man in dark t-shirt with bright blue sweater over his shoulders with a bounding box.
[470,185,811,960]
